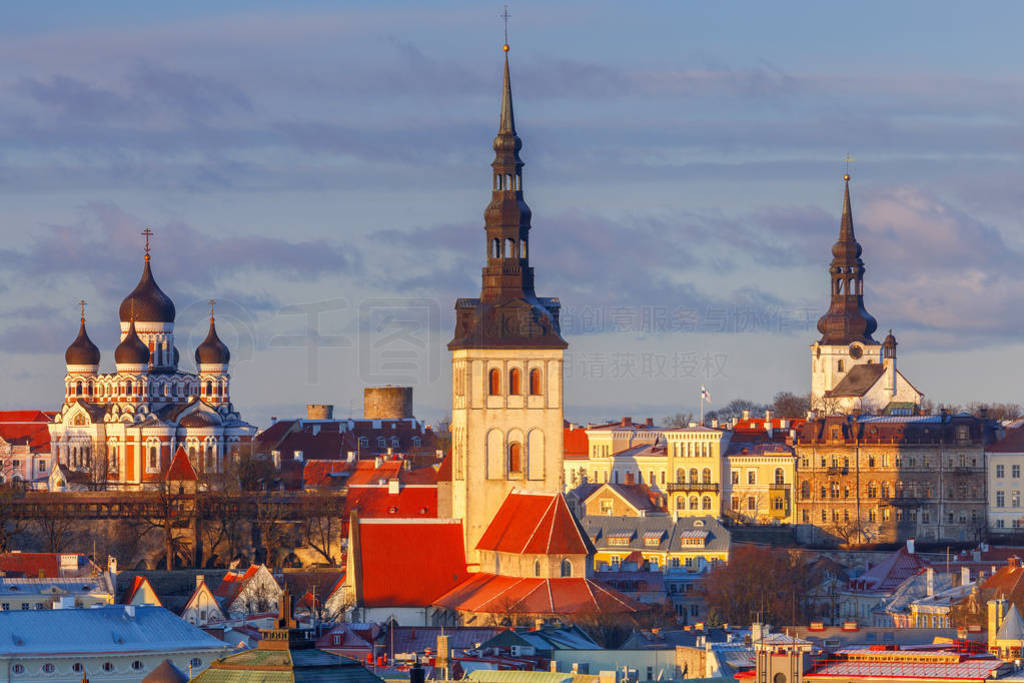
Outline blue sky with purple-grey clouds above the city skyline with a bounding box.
[0,0,1024,426]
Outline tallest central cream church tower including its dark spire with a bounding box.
[445,44,567,561]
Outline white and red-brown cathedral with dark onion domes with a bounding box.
[49,235,256,489]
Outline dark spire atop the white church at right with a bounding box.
[818,173,879,345]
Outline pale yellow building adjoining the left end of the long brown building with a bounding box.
[725,442,797,524]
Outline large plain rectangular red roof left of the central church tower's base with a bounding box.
[355,519,466,607]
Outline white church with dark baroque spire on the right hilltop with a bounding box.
[811,174,924,415]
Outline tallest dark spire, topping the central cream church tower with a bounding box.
[449,45,567,348]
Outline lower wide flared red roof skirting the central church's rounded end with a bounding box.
[434,573,643,614]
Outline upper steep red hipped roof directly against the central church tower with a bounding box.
[476,489,594,555]
